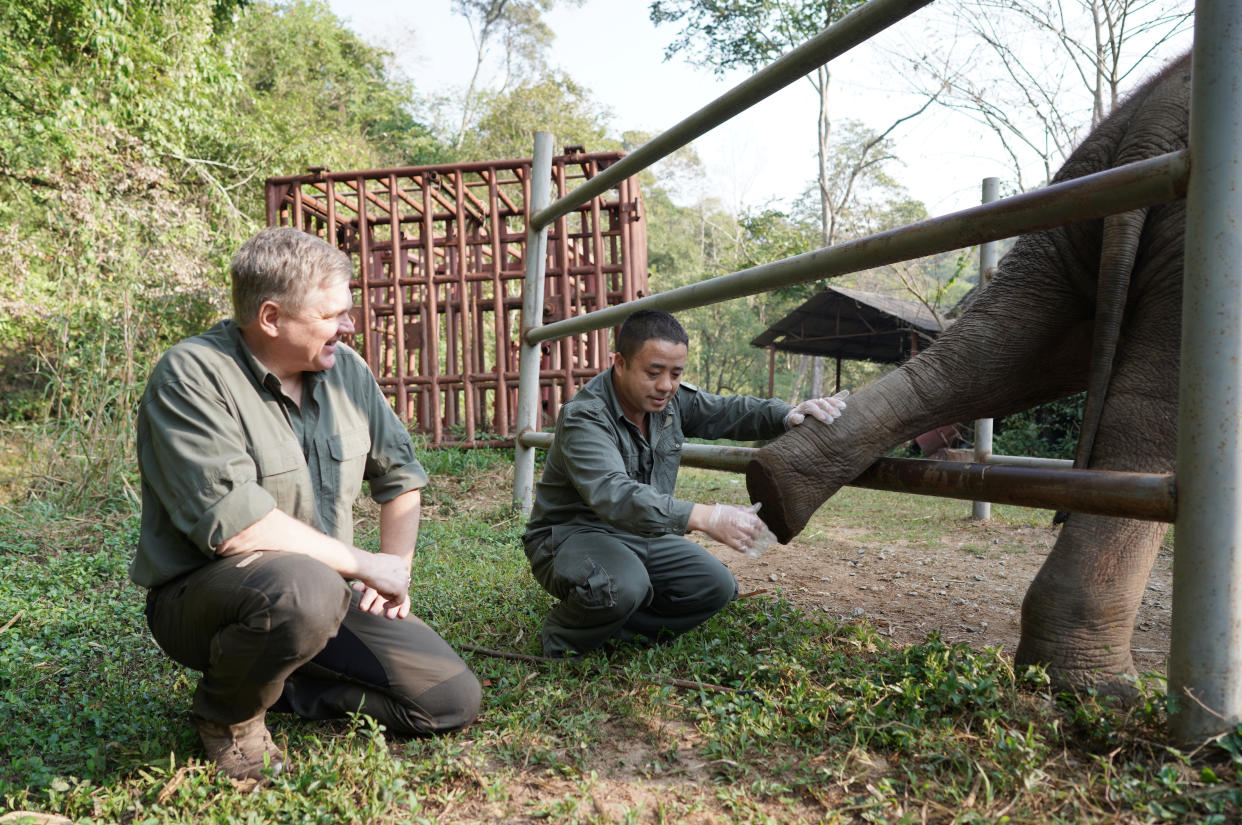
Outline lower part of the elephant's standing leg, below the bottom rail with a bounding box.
[1013,513,1169,700]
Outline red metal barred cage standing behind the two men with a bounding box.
[266,147,647,446]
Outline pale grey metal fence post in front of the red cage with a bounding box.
[513,132,553,516]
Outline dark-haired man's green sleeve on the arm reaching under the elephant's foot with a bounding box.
[555,411,694,537]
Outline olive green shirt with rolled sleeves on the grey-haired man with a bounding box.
[129,321,427,588]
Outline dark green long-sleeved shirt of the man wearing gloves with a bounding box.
[524,368,792,552]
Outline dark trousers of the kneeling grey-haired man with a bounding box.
[147,552,481,736]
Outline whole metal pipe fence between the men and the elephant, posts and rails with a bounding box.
[514,0,1242,741]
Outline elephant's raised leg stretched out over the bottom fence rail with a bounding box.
[746,242,1092,543]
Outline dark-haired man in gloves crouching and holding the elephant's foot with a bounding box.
[523,309,845,656]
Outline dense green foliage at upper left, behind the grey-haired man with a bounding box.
[0,0,441,506]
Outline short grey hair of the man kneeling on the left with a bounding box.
[229,226,354,327]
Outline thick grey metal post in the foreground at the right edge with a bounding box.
[1169,0,1242,743]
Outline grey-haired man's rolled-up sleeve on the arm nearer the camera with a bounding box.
[138,380,276,557]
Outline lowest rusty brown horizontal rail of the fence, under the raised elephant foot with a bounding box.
[518,432,1177,522]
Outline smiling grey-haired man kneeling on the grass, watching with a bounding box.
[129,227,481,779]
